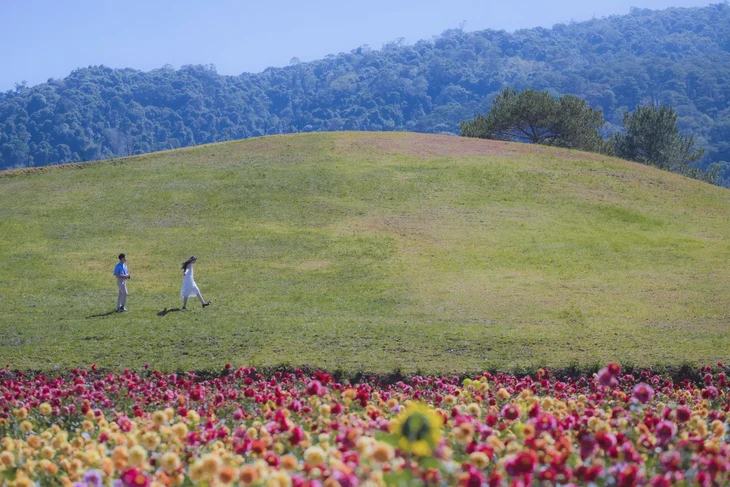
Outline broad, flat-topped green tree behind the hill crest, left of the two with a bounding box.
[461,88,605,151]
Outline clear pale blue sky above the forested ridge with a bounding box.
[0,0,716,91]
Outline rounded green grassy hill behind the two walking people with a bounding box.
[0,133,730,373]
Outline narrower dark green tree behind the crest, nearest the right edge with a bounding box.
[613,106,718,184]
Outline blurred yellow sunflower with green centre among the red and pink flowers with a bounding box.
[390,402,444,456]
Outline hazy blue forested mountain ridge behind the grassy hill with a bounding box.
[0,3,730,184]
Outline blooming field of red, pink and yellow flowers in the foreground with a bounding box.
[0,364,730,487]
